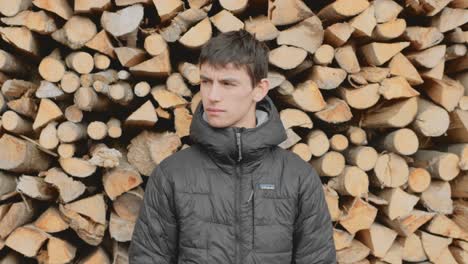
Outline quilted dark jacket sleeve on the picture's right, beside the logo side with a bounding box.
[292,168,336,264]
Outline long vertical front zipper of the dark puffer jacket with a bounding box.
[234,128,243,264]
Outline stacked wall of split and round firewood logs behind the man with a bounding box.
[0,0,468,264]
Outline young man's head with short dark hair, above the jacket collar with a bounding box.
[199,30,269,128]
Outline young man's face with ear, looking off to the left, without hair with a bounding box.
[200,63,260,128]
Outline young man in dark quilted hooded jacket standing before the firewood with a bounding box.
[129,30,336,264]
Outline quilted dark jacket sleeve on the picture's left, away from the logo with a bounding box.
[129,164,178,264]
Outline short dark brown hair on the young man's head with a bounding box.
[198,29,269,87]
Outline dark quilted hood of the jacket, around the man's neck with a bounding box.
[190,95,287,173]
